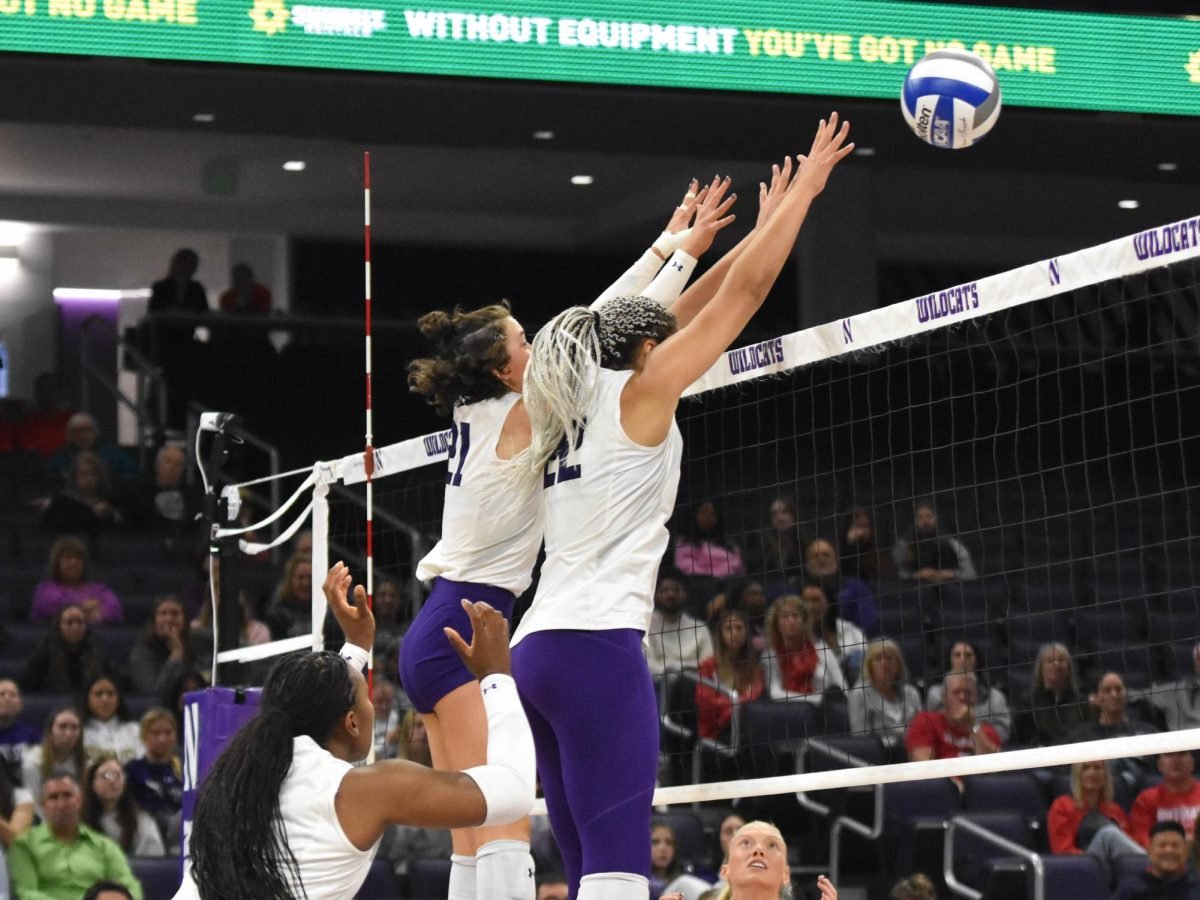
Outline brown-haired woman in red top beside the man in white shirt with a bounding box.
[696,608,766,738]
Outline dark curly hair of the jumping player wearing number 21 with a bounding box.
[408,300,512,415]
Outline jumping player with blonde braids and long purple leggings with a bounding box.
[514,114,853,900]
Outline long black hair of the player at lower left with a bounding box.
[191,652,356,900]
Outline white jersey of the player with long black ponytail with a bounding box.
[175,737,379,900]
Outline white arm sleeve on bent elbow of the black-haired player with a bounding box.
[463,674,536,826]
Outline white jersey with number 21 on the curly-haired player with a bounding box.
[416,392,542,594]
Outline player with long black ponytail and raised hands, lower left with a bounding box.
[176,563,535,900]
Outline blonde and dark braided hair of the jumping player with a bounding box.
[523,296,676,479]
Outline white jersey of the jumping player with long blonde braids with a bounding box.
[512,368,683,644]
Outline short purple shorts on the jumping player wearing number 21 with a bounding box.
[400,578,516,713]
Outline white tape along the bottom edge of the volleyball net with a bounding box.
[533,728,1200,816]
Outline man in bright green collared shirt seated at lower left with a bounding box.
[8,772,142,900]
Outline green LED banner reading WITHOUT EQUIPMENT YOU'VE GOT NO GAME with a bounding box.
[0,0,1200,115]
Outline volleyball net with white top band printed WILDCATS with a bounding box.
[218,218,1200,804]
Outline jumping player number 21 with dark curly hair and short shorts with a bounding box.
[400,182,720,900]
